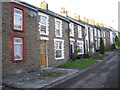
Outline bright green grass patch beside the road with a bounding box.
[57,60,97,69]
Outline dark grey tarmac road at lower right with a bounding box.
[50,52,120,88]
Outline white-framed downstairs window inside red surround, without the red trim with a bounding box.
[14,38,23,60]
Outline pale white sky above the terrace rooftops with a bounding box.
[22,0,120,29]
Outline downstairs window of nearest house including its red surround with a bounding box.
[11,33,26,62]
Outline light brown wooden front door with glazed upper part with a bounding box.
[40,41,47,67]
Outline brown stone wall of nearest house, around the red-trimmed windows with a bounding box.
[2,2,40,76]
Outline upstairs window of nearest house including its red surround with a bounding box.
[12,3,26,31]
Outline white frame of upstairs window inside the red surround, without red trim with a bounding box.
[13,8,23,31]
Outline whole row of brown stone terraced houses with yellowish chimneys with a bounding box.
[0,0,119,76]
